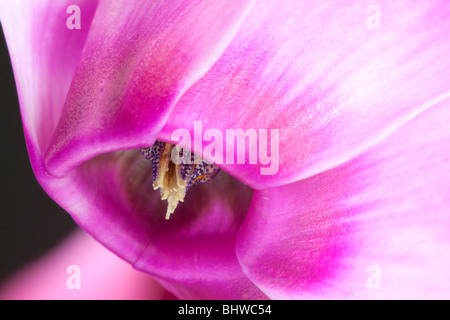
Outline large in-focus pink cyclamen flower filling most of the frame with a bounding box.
[0,0,450,299]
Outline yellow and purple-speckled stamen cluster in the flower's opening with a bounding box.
[141,141,219,220]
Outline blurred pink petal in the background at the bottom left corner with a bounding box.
[0,232,171,300]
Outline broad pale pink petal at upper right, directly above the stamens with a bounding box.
[159,0,450,189]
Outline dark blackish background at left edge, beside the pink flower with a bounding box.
[0,27,76,287]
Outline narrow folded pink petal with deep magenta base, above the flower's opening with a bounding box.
[45,0,254,176]
